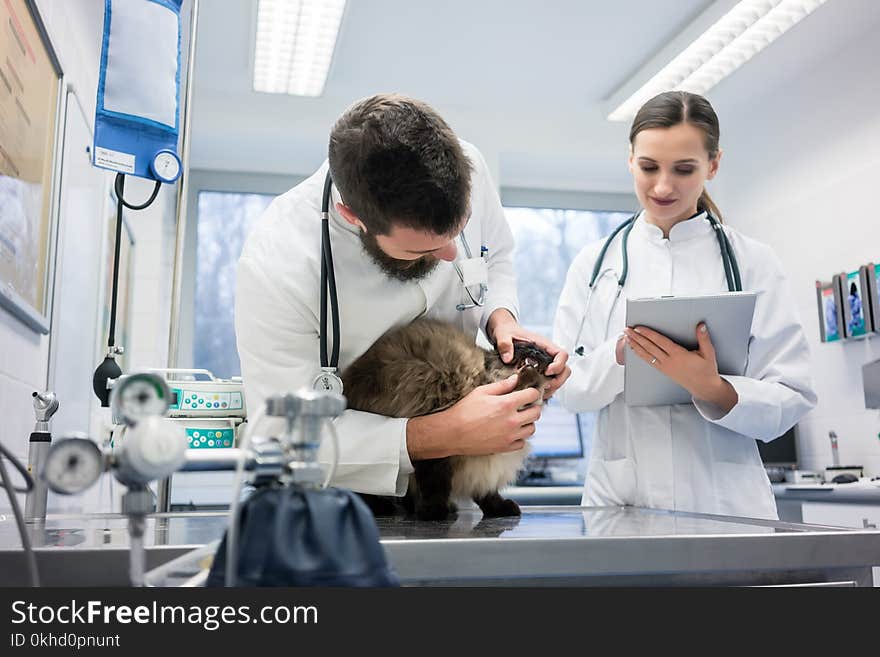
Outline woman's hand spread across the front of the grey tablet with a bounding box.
[624,323,739,413]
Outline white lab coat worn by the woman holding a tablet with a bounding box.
[554,214,816,518]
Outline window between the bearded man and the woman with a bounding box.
[504,207,631,472]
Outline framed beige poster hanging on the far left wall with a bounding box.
[0,0,61,333]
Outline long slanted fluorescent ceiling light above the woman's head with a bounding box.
[608,0,825,121]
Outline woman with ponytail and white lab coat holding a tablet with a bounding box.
[554,91,816,519]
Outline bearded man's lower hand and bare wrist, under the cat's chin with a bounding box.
[406,375,541,461]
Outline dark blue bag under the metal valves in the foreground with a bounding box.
[207,486,399,587]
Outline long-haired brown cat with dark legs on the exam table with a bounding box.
[342,319,553,520]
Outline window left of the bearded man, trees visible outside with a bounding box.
[193,191,274,379]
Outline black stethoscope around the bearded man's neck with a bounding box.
[312,171,488,394]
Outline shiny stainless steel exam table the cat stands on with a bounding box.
[0,506,880,586]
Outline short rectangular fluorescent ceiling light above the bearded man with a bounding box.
[254,0,345,96]
